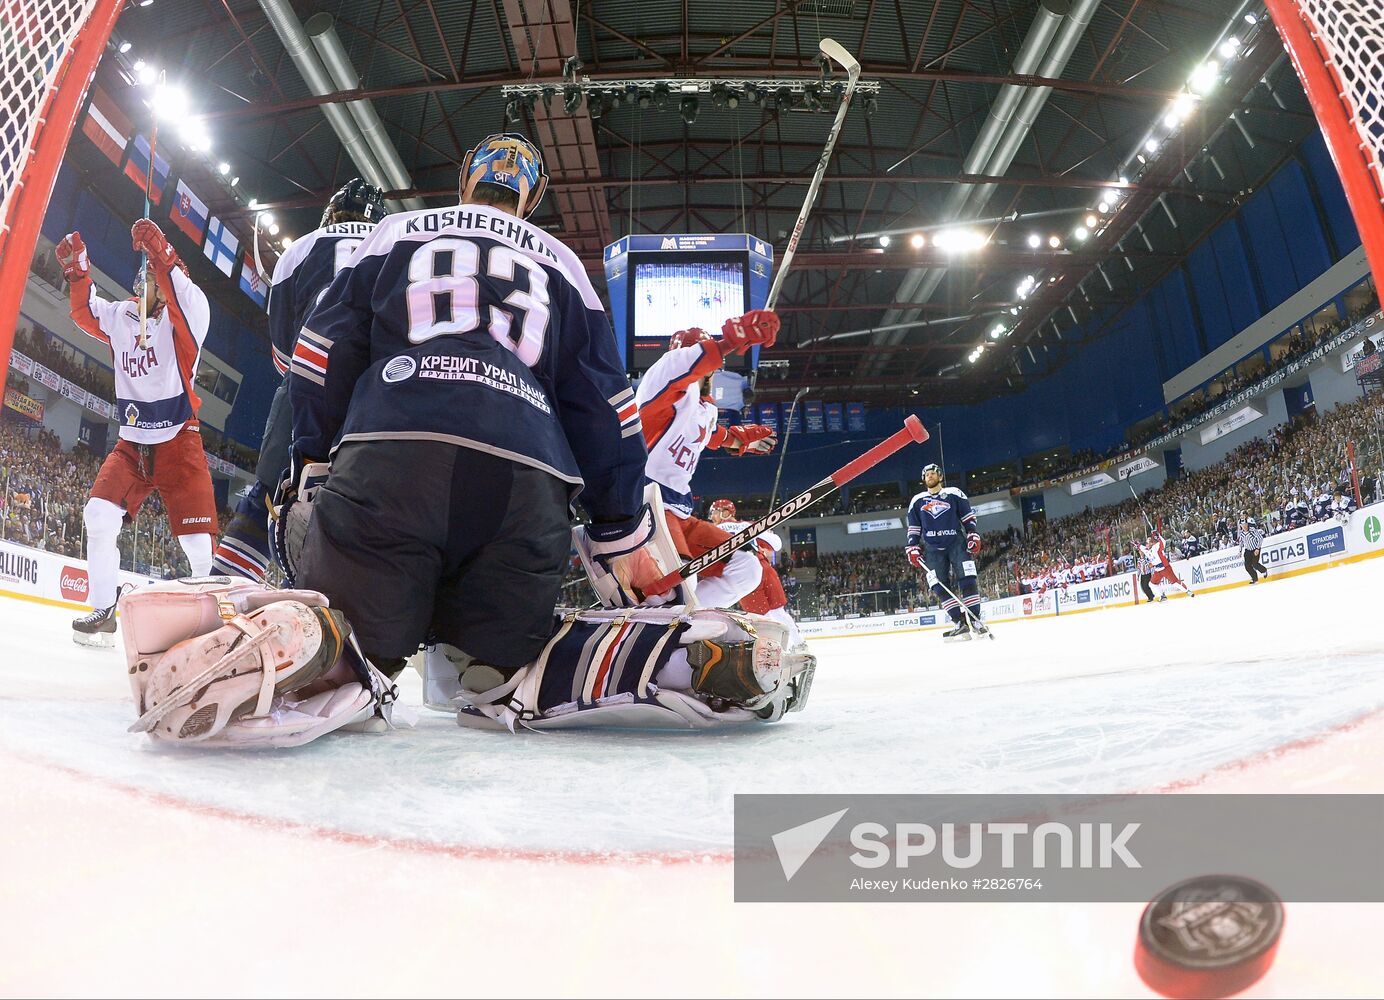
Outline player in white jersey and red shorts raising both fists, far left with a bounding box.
[57,219,216,645]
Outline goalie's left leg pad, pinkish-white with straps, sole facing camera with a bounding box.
[120,577,393,747]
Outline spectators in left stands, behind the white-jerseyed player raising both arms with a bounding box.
[0,419,231,580]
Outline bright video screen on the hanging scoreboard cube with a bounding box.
[632,260,745,342]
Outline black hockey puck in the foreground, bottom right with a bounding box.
[1133,876,1283,997]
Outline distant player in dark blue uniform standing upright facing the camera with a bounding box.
[904,465,990,639]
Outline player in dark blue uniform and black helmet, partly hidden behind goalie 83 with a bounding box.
[212,177,385,582]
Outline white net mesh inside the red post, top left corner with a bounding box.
[0,0,95,236]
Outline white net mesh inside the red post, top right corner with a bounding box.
[1297,0,1384,191]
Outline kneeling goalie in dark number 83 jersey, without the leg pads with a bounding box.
[275,134,663,676]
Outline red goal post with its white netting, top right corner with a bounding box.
[1265,0,1384,284]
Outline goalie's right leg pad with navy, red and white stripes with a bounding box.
[424,607,817,732]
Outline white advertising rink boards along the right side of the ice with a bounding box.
[799,503,1384,639]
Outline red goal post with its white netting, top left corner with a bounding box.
[0,0,123,393]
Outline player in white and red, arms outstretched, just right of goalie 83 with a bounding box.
[634,320,779,607]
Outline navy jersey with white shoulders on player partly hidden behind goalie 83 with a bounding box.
[268,223,375,375]
